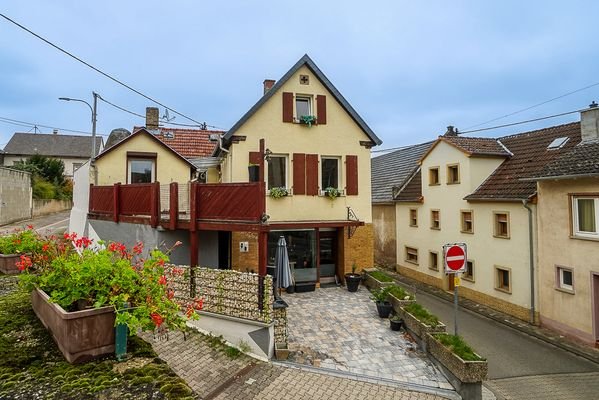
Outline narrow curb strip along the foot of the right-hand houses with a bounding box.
[385,269,599,364]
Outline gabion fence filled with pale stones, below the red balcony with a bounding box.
[166,265,274,323]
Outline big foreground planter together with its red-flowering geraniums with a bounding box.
[18,234,201,363]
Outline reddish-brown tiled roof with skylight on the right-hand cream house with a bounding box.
[465,122,580,200]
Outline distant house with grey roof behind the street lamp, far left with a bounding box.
[3,130,104,177]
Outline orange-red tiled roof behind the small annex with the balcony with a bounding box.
[133,127,225,158]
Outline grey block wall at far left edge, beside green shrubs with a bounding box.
[0,168,32,225]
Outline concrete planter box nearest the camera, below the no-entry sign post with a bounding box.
[425,333,489,400]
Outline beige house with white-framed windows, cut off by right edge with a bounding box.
[532,105,599,345]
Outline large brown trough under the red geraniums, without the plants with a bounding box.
[31,289,115,363]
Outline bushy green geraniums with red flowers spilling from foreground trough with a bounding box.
[20,234,202,362]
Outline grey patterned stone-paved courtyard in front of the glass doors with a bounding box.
[284,287,453,389]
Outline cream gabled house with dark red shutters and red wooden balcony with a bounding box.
[82,55,381,284]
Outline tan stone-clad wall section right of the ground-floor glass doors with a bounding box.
[342,224,374,273]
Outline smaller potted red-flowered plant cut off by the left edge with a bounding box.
[0,225,42,274]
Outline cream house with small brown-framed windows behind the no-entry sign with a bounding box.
[373,119,580,321]
